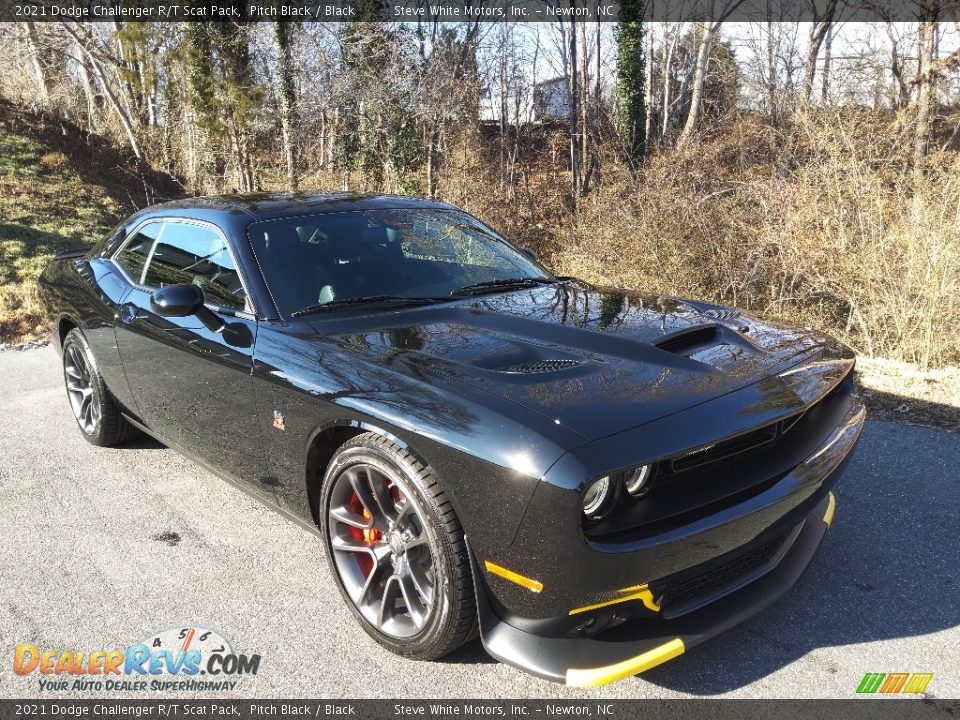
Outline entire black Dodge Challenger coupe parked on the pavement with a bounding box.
[41,195,864,685]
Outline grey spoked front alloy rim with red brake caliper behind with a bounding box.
[327,463,437,638]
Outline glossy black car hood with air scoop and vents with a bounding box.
[311,280,848,440]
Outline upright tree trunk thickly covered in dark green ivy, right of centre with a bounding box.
[617,0,647,163]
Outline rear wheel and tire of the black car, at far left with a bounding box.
[63,328,139,447]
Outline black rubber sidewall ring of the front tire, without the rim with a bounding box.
[318,438,454,657]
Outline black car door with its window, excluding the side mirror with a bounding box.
[113,219,259,478]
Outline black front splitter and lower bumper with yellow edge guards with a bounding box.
[474,386,865,685]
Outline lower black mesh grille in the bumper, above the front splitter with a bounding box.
[654,530,791,617]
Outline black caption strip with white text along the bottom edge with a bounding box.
[0,698,960,720]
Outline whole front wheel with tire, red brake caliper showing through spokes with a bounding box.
[318,433,477,660]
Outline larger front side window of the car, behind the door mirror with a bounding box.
[141,222,247,310]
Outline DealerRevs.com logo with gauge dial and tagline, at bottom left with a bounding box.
[13,627,260,692]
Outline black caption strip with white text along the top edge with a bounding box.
[0,0,960,23]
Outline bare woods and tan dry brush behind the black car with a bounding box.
[0,9,960,368]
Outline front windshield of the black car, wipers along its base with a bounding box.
[248,208,554,317]
